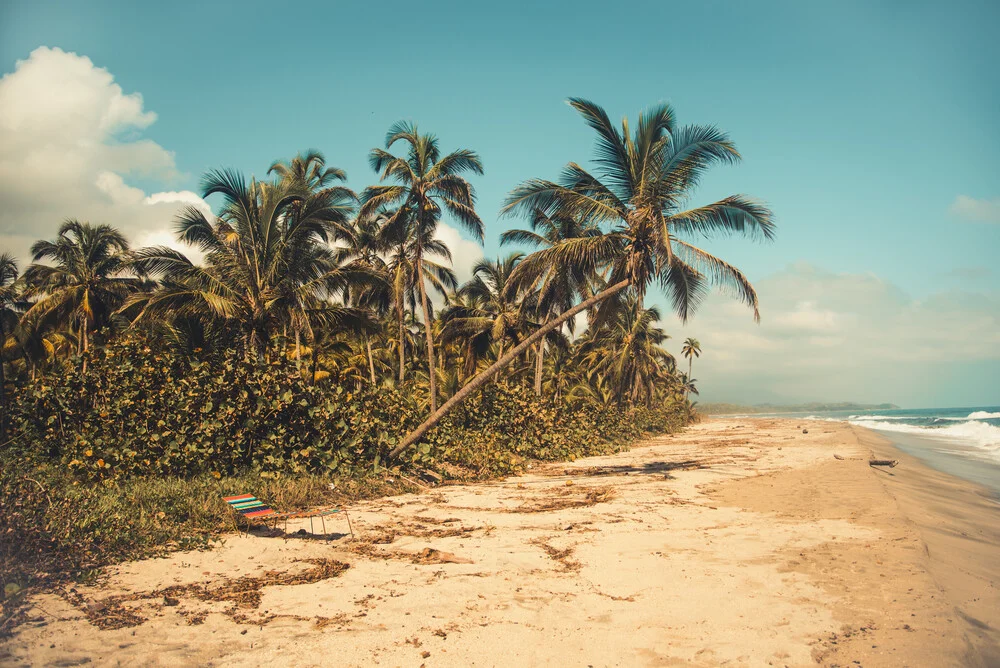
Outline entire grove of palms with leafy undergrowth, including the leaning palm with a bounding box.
[0,98,775,478]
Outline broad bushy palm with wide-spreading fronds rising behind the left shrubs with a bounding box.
[125,170,380,357]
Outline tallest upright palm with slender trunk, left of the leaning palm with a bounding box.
[360,121,483,413]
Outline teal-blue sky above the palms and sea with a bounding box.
[0,0,1000,405]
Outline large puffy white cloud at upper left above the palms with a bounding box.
[0,47,208,259]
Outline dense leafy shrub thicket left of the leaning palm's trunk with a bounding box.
[11,337,416,480]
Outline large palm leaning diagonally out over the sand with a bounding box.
[392,98,775,456]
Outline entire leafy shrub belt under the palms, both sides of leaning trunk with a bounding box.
[8,338,684,480]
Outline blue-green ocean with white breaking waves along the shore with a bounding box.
[732,406,1000,497]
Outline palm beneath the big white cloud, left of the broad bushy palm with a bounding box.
[24,220,145,373]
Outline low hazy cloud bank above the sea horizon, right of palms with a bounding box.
[665,264,1000,405]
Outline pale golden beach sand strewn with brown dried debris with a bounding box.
[0,419,1000,667]
